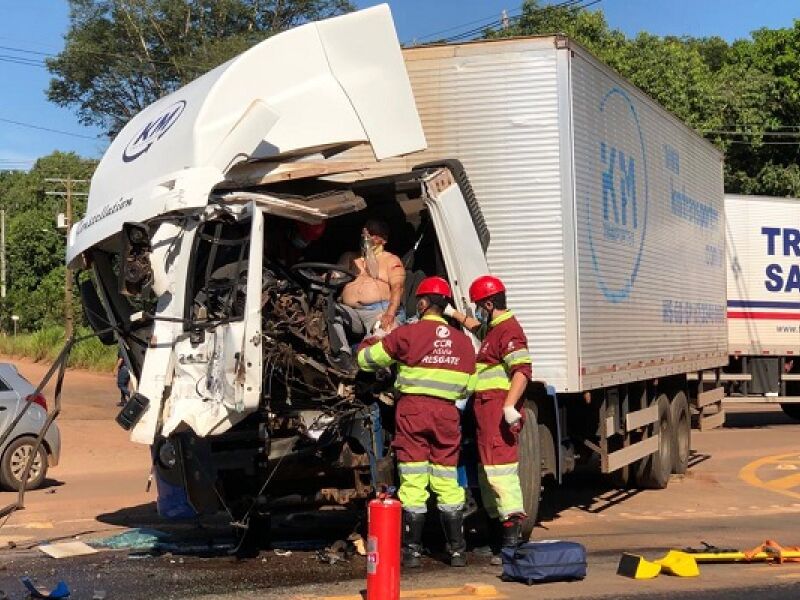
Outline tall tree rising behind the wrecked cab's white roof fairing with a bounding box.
[47,0,353,135]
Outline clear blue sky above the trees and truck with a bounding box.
[0,0,800,169]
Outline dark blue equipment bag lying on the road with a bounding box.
[501,540,586,585]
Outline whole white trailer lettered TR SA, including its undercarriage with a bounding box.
[719,194,800,419]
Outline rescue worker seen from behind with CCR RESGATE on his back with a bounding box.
[358,277,476,567]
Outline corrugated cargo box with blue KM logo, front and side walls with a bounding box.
[338,36,727,392]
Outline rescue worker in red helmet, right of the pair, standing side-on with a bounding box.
[446,275,533,564]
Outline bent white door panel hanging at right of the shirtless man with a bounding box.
[422,168,489,314]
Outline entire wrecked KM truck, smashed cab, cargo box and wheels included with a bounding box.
[68,6,728,535]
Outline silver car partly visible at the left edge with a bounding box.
[0,363,61,490]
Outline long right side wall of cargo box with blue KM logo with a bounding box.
[569,42,727,389]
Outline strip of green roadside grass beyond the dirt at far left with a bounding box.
[0,327,117,373]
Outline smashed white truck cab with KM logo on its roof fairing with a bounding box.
[68,6,482,522]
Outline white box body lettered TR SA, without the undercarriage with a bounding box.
[725,195,800,356]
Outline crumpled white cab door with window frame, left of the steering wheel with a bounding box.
[162,202,264,436]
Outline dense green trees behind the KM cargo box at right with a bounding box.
[486,0,800,196]
